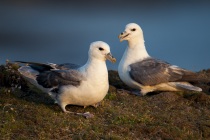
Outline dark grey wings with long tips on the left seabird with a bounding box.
[15,61,86,88]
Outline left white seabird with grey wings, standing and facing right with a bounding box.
[16,41,116,117]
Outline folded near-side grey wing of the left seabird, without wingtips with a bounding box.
[36,69,86,88]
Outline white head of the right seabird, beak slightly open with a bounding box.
[118,23,144,42]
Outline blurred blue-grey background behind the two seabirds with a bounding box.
[0,0,210,71]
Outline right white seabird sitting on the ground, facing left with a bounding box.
[118,23,202,95]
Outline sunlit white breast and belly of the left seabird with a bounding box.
[60,63,109,106]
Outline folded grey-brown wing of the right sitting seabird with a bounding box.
[129,58,191,85]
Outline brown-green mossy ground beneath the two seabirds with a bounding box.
[0,66,210,140]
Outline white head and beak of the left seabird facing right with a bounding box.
[89,41,116,63]
